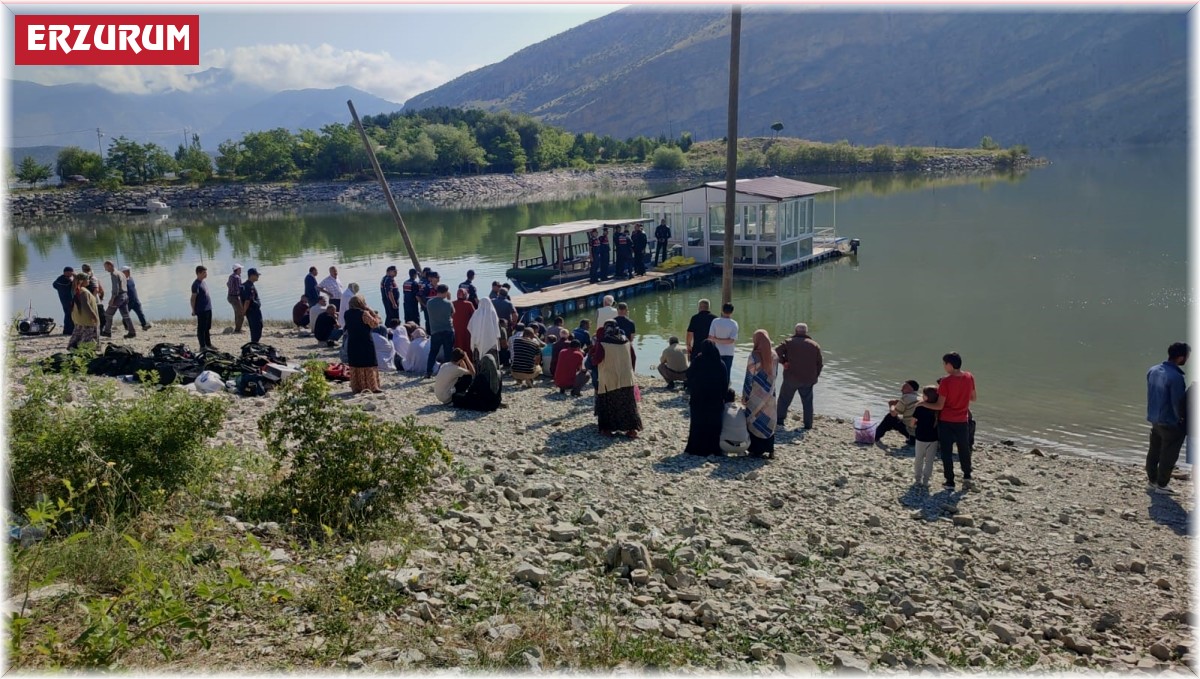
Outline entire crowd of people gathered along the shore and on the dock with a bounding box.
[53,257,1190,494]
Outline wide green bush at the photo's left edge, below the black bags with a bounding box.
[8,372,227,519]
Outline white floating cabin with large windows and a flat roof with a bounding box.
[640,176,850,274]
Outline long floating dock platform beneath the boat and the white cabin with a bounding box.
[512,239,845,318]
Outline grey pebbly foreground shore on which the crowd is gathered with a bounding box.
[10,323,1194,674]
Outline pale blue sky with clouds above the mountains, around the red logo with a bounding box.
[6,2,623,103]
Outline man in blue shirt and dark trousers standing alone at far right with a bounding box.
[1146,342,1192,495]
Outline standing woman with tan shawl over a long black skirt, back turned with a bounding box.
[592,322,642,439]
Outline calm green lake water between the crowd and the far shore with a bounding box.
[5,150,1189,461]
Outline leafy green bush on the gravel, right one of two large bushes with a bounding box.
[252,362,450,534]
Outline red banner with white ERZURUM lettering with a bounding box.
[13,14,200,66]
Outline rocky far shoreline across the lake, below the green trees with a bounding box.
[7,155,1036,217]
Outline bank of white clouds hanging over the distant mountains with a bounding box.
[13,44,464,103]
